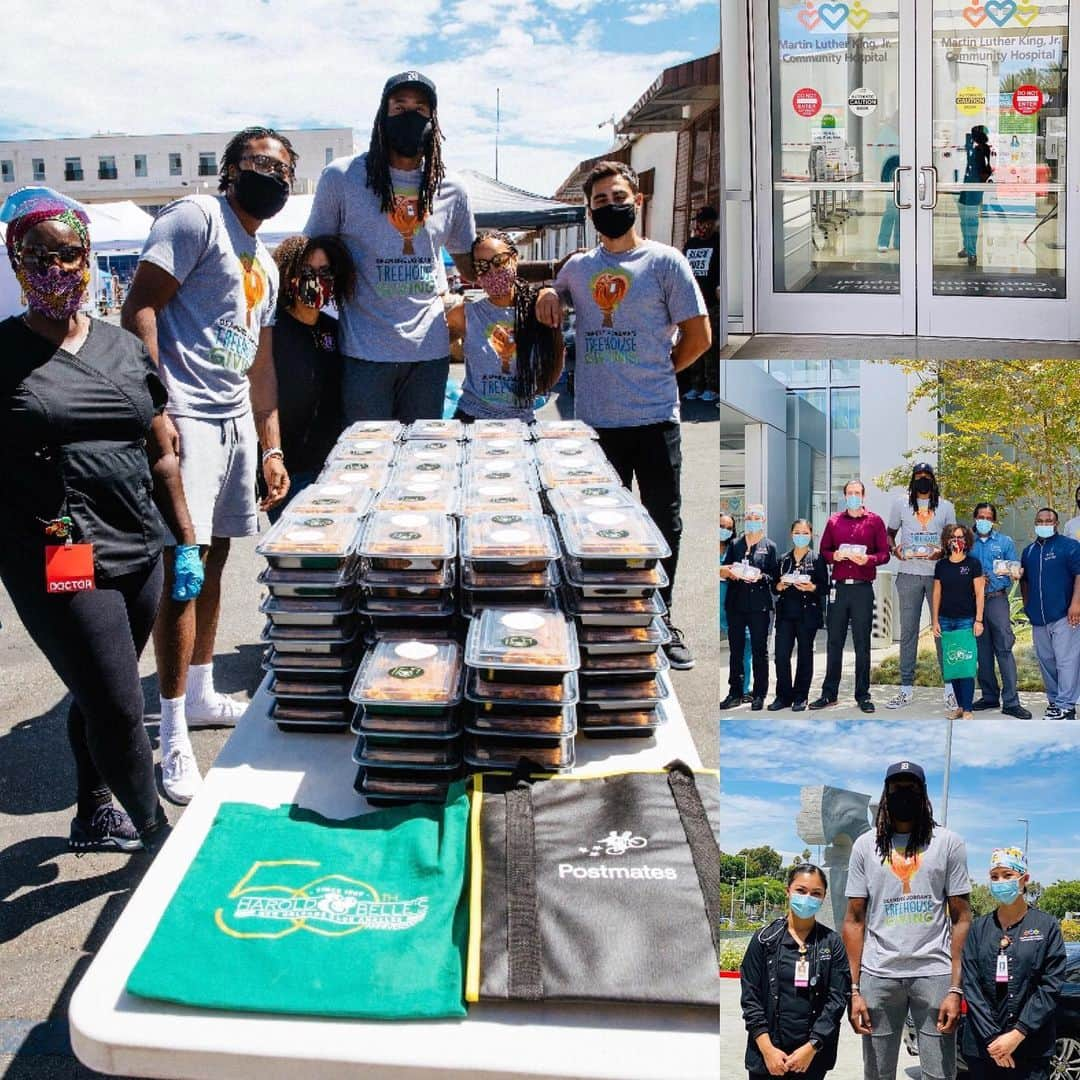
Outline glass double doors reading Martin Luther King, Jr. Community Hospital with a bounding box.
[753,0,1080,339]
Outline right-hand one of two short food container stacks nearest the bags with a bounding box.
[464,607,579,771]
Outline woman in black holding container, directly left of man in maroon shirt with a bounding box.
[769,517,828,713]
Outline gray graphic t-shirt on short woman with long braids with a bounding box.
[458,296,532,423]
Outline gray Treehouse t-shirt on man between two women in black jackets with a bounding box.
[845,826,971,978]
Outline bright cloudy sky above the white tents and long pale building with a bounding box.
[0,0,719,194]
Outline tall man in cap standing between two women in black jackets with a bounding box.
[842,761,971,1080]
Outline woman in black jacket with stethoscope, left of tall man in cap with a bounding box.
[740,863,851,1080]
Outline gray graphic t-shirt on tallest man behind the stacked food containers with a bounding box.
[305,153,476,363]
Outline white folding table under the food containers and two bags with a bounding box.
[68,676,719,1080]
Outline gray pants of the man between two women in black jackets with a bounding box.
[859,971,956,1080]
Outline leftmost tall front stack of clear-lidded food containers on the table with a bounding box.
[256,481,373,731]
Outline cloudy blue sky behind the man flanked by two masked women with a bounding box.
[720,718,1080,885]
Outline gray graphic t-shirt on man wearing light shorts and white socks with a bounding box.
[139,195,278,420]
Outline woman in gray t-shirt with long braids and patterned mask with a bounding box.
[446,232,563,423]
